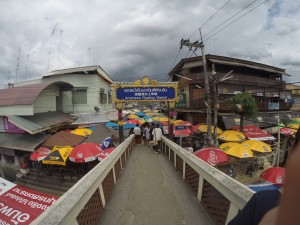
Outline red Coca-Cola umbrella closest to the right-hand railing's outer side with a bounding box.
[194,148,229,166]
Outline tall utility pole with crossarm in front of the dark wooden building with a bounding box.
[180,33,213,147]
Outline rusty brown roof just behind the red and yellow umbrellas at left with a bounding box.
[41,131,85,148]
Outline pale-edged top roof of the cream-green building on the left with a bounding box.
[43,66,113,83]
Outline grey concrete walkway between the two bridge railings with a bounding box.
[98,146,214,225]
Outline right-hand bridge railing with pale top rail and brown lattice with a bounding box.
[161,137,254,225]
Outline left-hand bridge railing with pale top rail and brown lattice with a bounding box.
[31,135,134,225]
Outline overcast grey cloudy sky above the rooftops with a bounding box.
[0,0,300,88]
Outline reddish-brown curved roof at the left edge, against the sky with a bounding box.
[0,82,72,106]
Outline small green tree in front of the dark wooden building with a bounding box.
[230,93,258,132]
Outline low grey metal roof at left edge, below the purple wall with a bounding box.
[0,133,50,152]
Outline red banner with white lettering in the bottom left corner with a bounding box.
[0,177,58,225]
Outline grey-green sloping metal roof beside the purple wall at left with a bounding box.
[8,112,77,134]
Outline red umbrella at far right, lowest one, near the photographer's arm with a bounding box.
[260,167,285,184]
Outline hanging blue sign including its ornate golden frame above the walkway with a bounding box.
[112,77,178,103]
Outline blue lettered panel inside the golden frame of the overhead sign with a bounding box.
[116,87,176,101]
